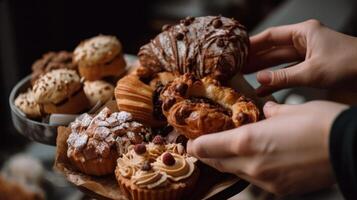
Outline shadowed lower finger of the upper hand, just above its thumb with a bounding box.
[243,46,302,73]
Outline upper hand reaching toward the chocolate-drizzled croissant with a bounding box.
[243,20,357,95]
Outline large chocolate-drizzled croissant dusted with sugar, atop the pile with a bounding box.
[138,16,249,80]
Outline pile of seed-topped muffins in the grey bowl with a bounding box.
[15,35,126,121]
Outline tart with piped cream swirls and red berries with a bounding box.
[115,140,199,200]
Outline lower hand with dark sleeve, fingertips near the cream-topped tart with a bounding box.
[187,101,347,194]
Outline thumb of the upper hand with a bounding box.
[257,62,306,95]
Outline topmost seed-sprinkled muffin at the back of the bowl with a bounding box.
[73,35,126,81]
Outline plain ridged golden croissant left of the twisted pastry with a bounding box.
[114,72,174,127]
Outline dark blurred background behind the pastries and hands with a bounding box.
[0,0,357,199]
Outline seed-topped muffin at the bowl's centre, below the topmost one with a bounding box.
[33,69,89,114]
